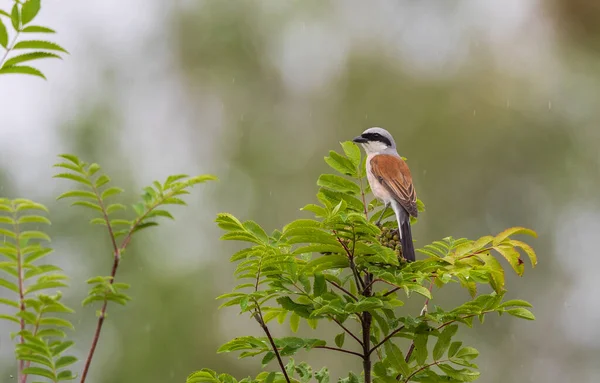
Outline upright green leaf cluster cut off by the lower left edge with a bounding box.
[0,199,77,382]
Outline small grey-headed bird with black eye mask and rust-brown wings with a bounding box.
[352,127,418,262]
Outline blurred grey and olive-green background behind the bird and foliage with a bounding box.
[0,0,600,383]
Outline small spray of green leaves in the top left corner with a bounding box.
[0,0,68,79]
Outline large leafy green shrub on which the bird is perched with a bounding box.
[187,142,537,383]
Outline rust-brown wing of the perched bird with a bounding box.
[370,154,418,217]
